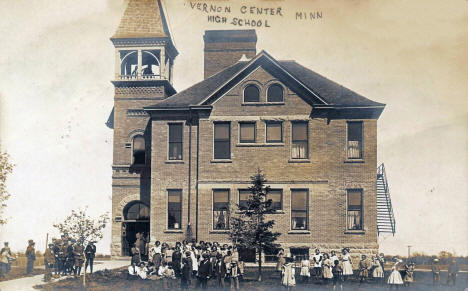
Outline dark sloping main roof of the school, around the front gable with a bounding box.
[145,51,384,109]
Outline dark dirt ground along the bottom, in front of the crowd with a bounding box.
[35,268,468,291]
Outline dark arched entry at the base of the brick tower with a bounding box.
[122,201,150,256]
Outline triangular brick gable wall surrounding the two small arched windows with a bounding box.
[211,66,312,116]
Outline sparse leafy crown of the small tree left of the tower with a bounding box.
[54,207,109,247]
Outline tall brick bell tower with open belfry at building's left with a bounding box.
[110,0,178,257]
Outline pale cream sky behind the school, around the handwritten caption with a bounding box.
[0,0,468,255]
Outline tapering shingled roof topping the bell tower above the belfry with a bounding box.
[112,0,171,39]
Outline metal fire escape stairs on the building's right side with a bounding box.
[377,163,395,235]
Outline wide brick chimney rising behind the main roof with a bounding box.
[203,29,257,79]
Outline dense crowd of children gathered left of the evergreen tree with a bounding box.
[128,241,244,290]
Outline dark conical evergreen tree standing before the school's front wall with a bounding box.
[229,169,281,281]
